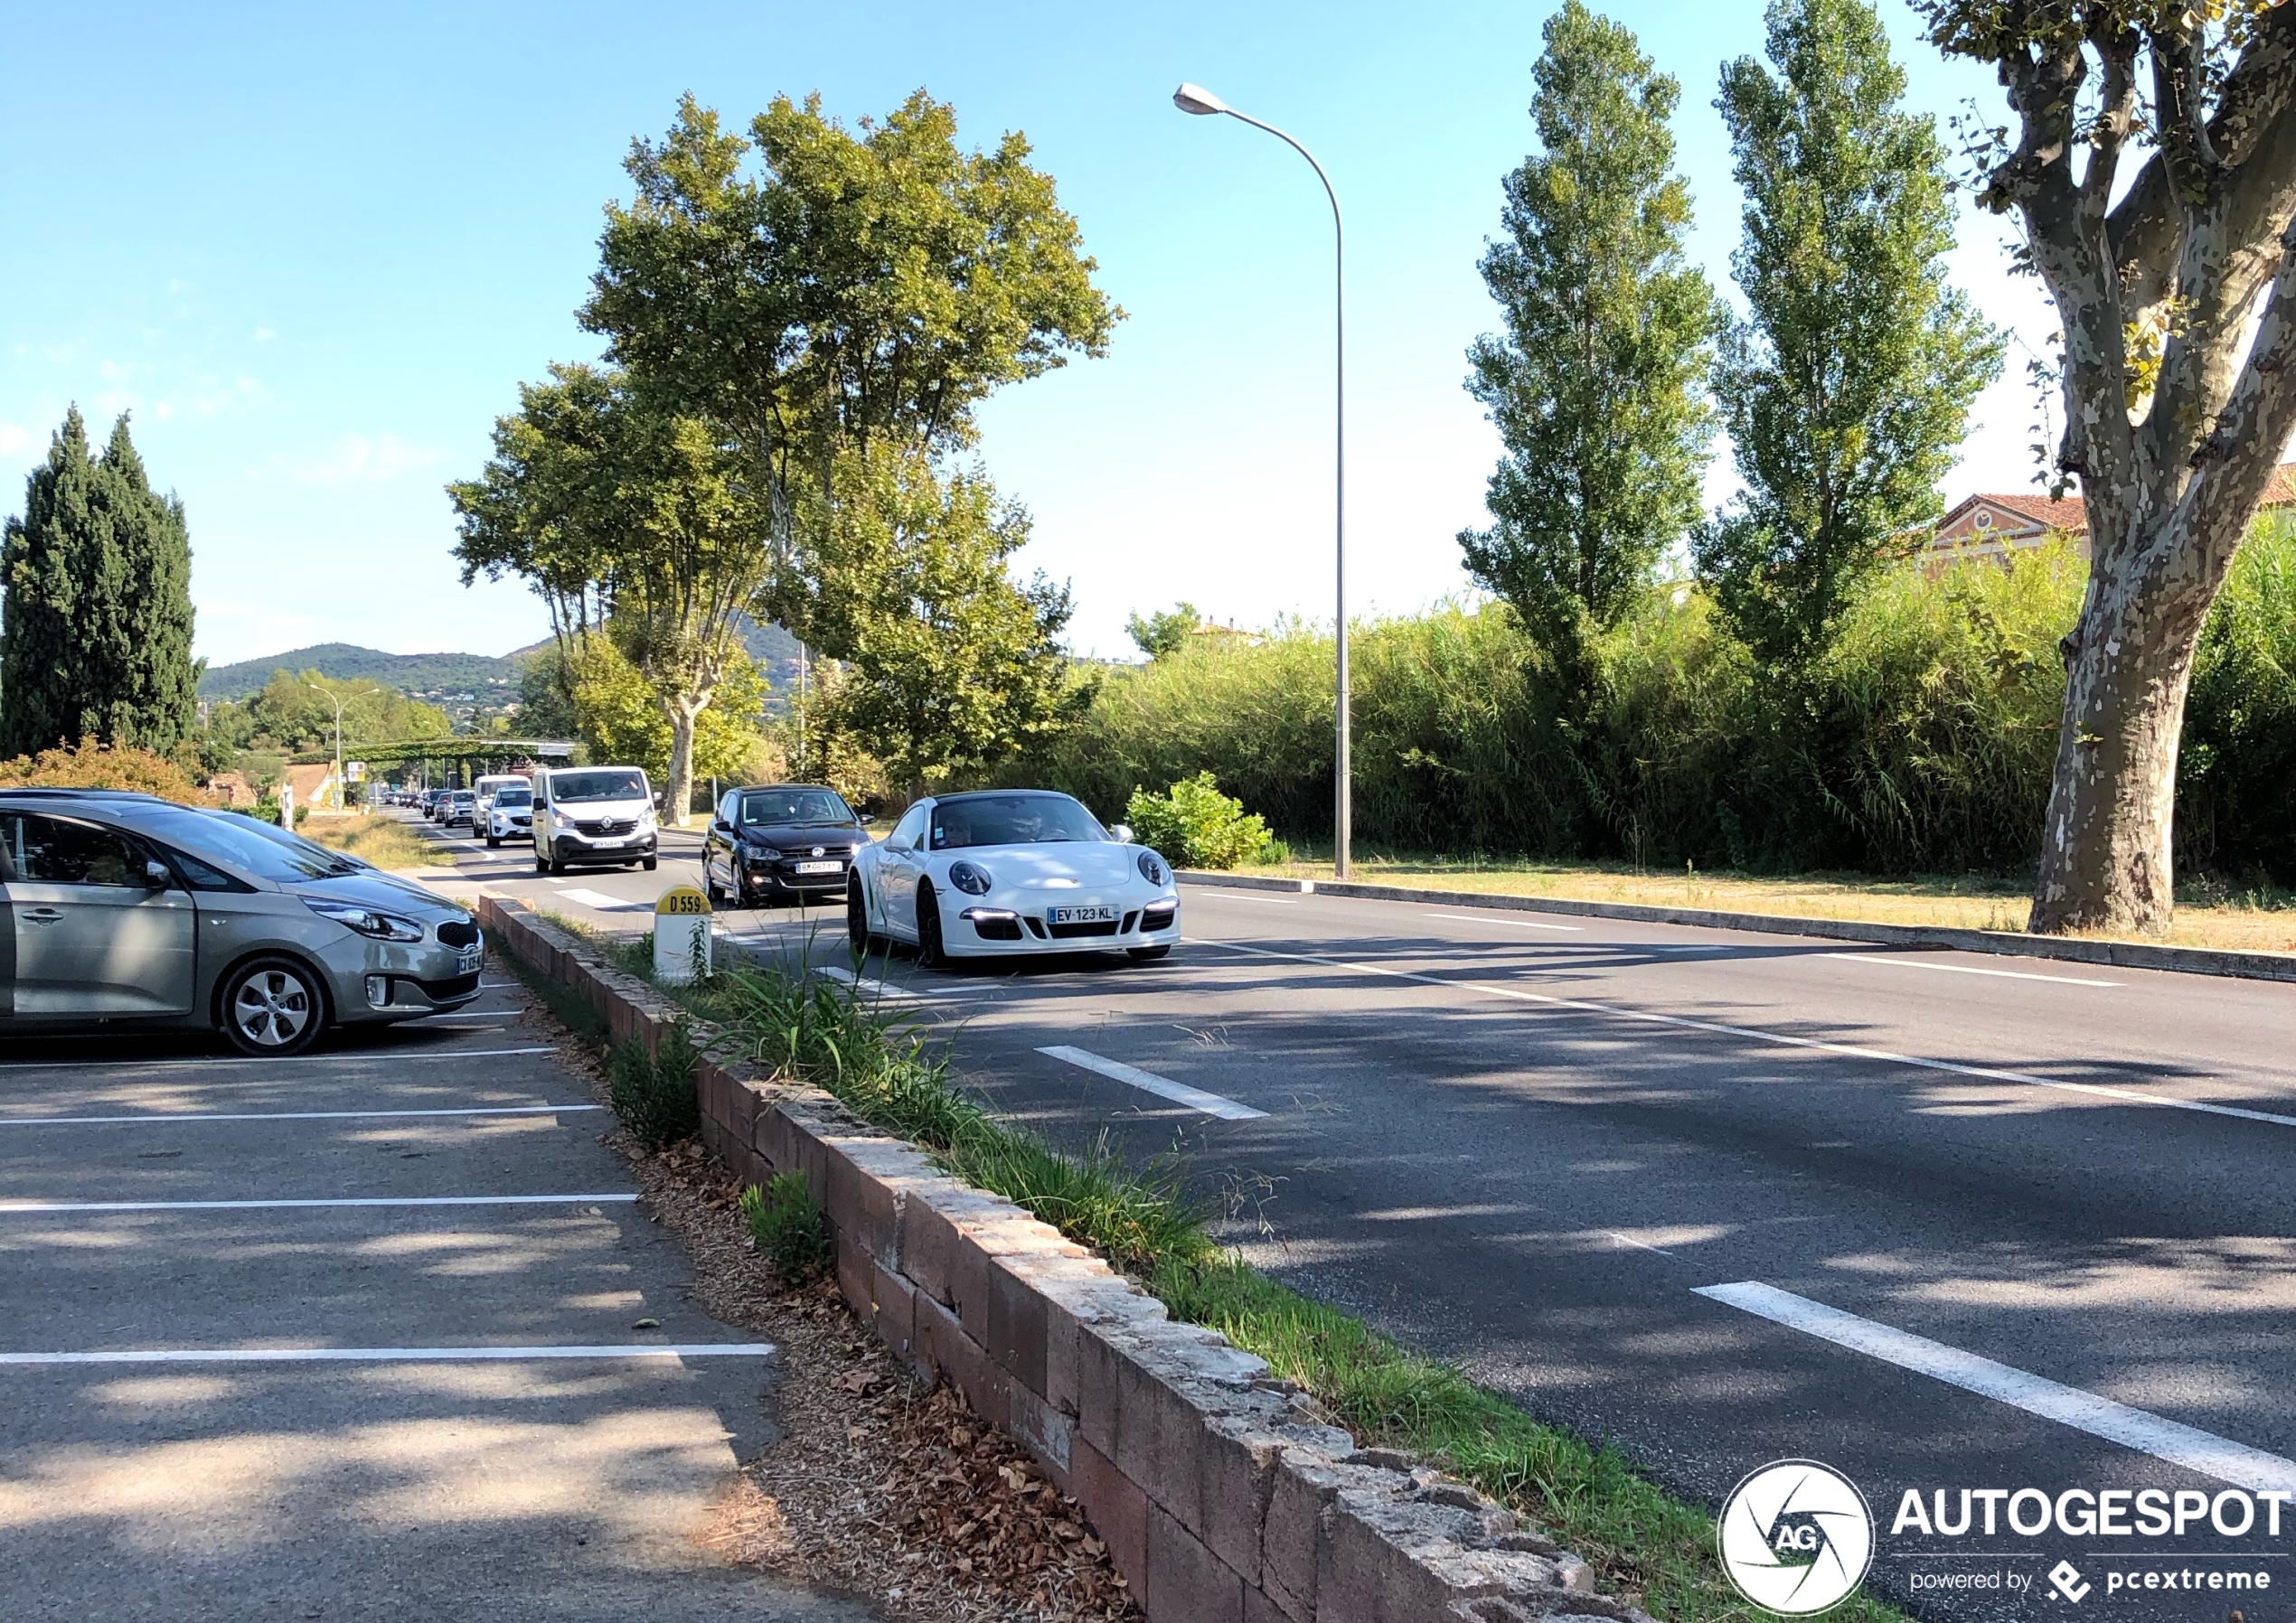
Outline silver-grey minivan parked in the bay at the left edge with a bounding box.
[0,790,485,1056]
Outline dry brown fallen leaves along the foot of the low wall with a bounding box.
[512,978,1139,1623]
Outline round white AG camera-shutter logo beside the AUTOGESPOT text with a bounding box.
[1719,1460,1874,1616]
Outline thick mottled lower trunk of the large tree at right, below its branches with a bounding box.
[2029,514,2229,934]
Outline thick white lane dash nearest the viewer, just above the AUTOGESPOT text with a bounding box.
[1697,1279,2296,1492]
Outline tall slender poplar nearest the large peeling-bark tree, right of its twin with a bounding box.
[1697,0,2002,666]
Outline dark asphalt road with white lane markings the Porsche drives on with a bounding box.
[422,817,2296,1623]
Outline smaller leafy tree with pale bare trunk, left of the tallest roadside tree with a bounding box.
[447,365,771,824]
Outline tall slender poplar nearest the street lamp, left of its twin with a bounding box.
[1458,0,1717,643]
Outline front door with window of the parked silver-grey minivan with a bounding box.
[0,812,200,1019]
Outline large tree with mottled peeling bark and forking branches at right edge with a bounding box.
[1922,0,2296,932]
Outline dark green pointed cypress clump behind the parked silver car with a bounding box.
[0,407,197,757]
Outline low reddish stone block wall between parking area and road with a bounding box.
[480,897,1649,1623]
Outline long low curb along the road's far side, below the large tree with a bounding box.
[1175,868,2296,980]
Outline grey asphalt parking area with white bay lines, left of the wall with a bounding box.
[0,969,870,1623]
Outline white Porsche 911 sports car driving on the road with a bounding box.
[845,790,1181,964]
